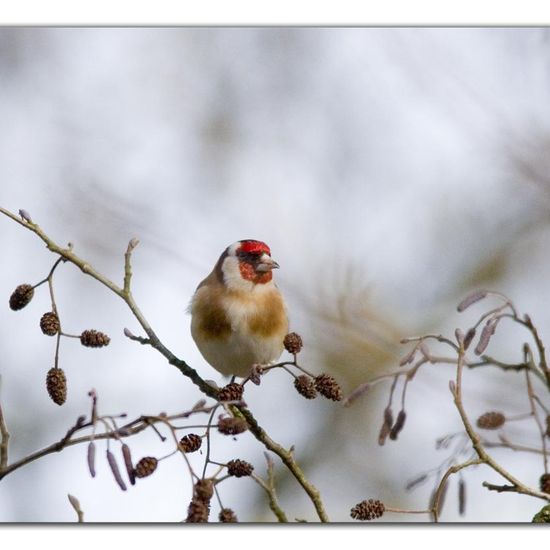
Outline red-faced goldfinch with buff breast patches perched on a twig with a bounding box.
[189,239,289,378]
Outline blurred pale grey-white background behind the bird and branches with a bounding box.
[0,27,550,522]
